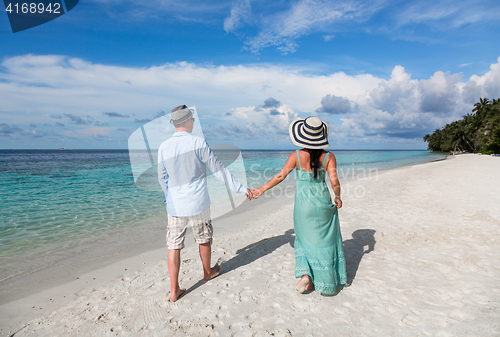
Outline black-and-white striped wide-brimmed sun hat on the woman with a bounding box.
[288,117,330,149]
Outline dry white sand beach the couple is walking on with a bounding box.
[0,154,500,337]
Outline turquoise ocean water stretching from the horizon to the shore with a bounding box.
[0,150,444,281]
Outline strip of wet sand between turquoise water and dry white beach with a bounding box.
[0,153,447,305]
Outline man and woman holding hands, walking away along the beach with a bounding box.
[158,105,347,301]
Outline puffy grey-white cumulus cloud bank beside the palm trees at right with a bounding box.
[314,58,500,143]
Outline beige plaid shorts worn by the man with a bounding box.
[167,207,214,249]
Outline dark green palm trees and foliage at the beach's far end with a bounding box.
[424,98,500,154]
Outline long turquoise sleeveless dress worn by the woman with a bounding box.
[293,150,347,294]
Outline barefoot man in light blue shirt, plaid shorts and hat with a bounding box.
[158,105,252,302]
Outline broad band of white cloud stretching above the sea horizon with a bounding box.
[0,55,500,148]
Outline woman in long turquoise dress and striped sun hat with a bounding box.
[252,117,347,295]
